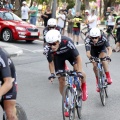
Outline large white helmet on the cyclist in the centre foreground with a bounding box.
[45,29,61,43]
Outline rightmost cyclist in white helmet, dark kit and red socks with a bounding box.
[85,28,112,92]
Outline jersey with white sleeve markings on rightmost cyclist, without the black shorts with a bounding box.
[85,35,110,51]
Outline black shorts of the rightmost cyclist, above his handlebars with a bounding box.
[91,45,107,57]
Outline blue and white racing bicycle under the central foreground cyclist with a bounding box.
[60,71,82,120]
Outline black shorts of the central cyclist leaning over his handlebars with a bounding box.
[54,53,76,73]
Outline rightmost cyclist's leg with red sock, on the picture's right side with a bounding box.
[99,50,112,84]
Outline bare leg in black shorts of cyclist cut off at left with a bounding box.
[2,83,18,120]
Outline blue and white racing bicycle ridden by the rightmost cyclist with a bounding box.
[86,58,108,106]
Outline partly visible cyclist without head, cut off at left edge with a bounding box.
[0,48,18,120]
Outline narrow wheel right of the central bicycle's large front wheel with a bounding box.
[76,90,82,119]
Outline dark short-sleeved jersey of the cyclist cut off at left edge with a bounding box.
[0,48,16,82]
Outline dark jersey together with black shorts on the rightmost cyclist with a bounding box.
[85,35,110,57]
